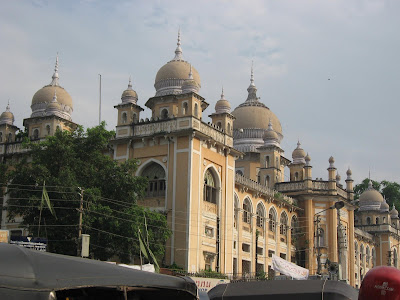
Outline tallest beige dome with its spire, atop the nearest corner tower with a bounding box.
[154,33,201,96]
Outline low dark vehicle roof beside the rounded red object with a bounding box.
[208,280,358,300]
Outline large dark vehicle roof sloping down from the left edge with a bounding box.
[0,243,197,299]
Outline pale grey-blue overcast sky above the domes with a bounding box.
[0,0,400,183]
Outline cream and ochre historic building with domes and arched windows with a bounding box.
[0,34,400,286]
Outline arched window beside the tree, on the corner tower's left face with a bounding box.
[141,162,166,197]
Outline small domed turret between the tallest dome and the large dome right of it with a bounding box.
[209,87,235,136]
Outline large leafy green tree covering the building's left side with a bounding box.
[6,123,170,262]
